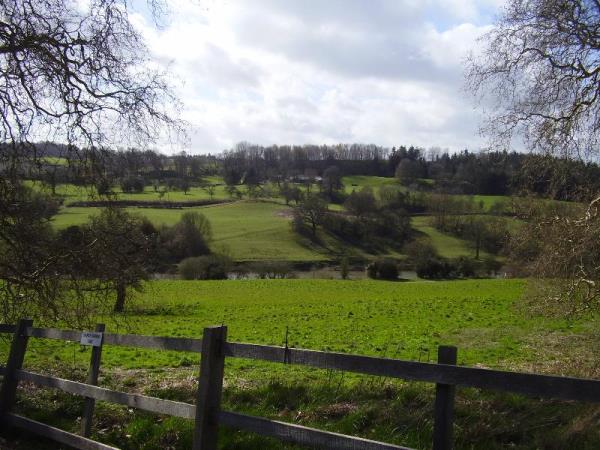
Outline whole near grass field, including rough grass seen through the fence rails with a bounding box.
[9,280,600,450]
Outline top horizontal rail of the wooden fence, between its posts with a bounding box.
[0,325,600,403]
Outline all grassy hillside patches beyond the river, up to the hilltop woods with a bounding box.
[47,176,502,261]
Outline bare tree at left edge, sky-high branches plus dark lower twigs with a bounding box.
[0,0,182,320]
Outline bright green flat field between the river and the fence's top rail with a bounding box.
[17,280,583,368]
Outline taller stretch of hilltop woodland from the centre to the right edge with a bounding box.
[220,143,600,200]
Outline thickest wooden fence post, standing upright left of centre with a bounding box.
[192,326,227,450]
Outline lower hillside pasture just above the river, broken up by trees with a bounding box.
[53,207,496,261]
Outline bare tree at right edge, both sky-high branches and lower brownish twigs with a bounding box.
[466,0,600,311]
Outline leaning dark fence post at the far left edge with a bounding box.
[0,319,33,418]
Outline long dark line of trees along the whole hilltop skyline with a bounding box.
[24,142,600,201]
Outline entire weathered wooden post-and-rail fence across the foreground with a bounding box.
[0,320,600,450]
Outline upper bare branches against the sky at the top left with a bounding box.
[0,0,183,156]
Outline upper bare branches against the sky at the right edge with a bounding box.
[466,0,600,156]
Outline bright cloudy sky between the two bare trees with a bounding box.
[135,0,502,153]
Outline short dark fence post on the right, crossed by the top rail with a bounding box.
[433,346,457,450]
